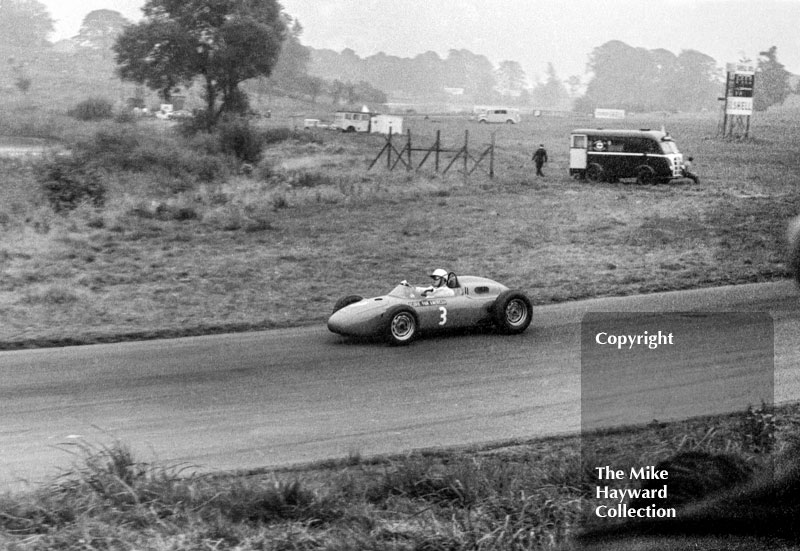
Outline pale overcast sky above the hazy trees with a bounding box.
[39,0,800,82]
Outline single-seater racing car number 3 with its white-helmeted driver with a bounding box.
[328,272,532,345]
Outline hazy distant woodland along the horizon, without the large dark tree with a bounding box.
[0,0,797,112]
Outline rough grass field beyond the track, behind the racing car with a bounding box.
[0,104,800,348]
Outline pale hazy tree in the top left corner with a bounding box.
[0,0,53,48]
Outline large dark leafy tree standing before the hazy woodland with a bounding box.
[114,0,286,128]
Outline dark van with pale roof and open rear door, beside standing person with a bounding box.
[569,128,683,184]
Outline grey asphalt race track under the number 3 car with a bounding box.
[0,281,800,491]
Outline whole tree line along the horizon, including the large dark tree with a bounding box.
[0,0,796,125]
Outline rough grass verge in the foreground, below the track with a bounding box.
[0,405,788,551]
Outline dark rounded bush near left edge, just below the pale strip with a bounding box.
[39,157,106,216]
